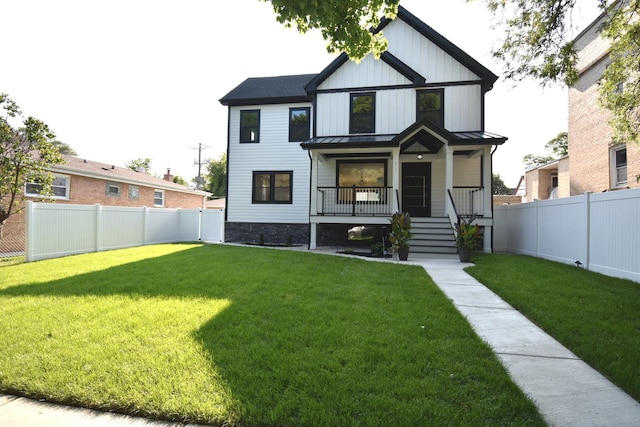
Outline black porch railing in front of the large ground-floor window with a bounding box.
[316,186,393,216]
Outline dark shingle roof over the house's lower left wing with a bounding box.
[220,74,316,105]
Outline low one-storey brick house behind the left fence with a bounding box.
[0,155,209,253]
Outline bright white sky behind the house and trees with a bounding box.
[0,0,598,187]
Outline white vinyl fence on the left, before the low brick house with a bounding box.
[25,202,224,262]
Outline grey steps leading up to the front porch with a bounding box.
[409,218,458,254]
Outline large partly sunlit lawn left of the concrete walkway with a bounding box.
[0,244,544,426]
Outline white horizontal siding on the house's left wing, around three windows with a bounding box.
[227,104,313,224]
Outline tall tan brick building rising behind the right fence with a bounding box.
[568,10,640,196]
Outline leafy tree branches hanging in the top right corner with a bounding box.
[484,0,640,143]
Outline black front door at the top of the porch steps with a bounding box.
[402,163,431,217]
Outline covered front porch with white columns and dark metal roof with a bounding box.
[302,120,506,251]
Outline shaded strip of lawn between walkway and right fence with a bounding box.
[466,254,640,401]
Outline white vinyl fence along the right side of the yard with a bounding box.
[493,189,640,282]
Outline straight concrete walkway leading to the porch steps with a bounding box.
[409,256,640,427]
